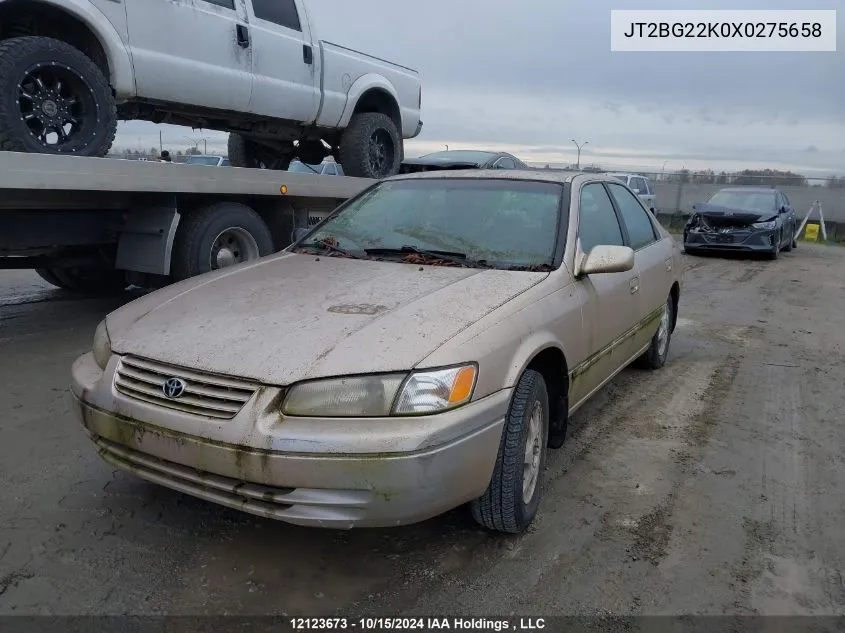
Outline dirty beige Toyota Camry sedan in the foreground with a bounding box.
[73,170,682,533]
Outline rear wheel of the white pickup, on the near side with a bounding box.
[339,112,403,178]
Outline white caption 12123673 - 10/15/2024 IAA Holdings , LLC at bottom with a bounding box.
[288,616,546,631]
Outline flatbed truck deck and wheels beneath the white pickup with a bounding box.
[0,152,375,292]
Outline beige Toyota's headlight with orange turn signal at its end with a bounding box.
[282,365,477,417]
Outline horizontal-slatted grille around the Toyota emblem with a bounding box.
[114,356,258,419]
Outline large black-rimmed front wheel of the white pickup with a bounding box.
[0,36,117,156]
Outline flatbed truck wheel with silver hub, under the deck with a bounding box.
[171,202,275,280]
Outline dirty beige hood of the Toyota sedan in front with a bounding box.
[107,253,548,385]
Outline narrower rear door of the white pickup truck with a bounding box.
[247,0,322,123]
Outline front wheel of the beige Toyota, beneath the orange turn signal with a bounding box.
[471,369,549,534]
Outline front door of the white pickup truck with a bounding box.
[126,0,252,112]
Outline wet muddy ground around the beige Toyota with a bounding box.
[0,245,845,615]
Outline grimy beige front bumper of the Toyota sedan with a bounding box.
[72,354,512,529]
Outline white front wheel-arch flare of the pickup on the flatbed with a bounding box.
[21,0,136,100]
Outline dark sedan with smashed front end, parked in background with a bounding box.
[684,187,798,259]
